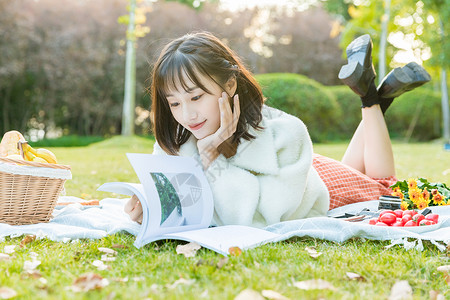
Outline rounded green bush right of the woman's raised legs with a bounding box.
[386,87,442,141]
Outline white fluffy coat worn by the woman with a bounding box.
[153,106,329,227]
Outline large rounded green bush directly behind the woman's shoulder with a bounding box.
[256,73,341,142]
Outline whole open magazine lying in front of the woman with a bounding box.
[98,153,280,255]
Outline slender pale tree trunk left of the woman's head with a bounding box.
[122,0,136,135]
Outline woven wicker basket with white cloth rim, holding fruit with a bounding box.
[0,158,71,225]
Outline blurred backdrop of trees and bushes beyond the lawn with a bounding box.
[0,0,450,145]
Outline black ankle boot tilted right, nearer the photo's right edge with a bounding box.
[378,62,431,113]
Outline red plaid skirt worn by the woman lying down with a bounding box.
[313,154,397,209]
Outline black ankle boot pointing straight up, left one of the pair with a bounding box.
[338,34,376,97]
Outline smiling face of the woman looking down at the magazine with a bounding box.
[167,75,232,139]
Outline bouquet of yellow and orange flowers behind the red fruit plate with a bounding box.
[391,178,450,210]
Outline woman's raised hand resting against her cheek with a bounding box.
[197,92,241,169]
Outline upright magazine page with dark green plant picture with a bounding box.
[127,153,214,247]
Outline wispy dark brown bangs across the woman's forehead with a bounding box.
[155,51,217,98]
